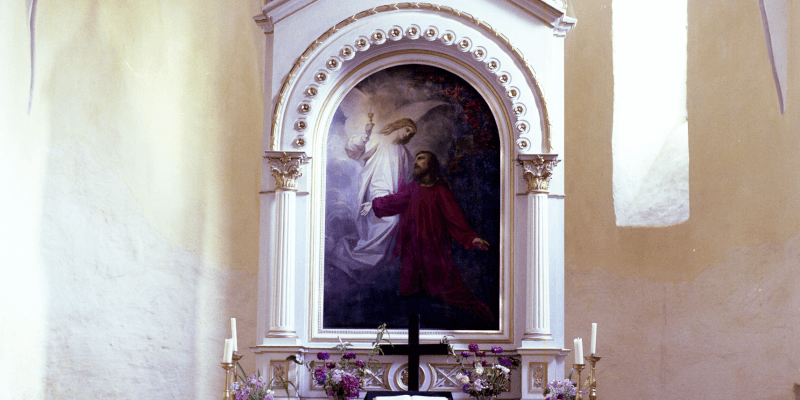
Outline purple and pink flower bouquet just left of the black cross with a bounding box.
[287,324,391,399]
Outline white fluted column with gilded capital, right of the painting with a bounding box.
[517,154,560,342]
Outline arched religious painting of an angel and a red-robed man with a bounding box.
[323,64,501,330]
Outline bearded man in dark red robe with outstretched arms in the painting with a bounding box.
[361,151,495,321]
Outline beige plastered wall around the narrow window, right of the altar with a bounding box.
[565,0,800,399]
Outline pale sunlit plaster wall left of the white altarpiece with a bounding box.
[0,0,264,399]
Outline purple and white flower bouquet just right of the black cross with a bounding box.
[450,343,520,398]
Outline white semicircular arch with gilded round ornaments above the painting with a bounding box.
[269,3,553,154]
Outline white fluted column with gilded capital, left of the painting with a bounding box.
[264,151,308,341]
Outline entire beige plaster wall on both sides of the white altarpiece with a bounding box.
[0,0,800,399]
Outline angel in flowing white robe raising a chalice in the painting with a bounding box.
[332,118,417,281]
